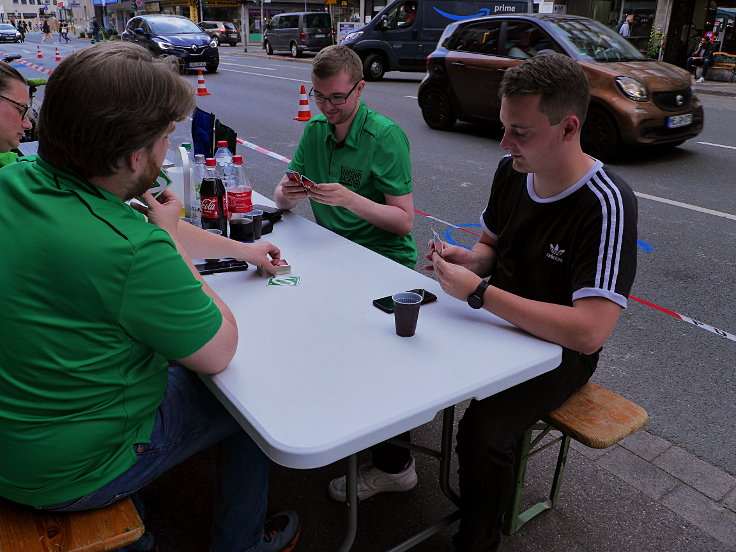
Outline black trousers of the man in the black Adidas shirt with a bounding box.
[453,349,598,552]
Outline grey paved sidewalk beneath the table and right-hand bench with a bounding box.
[142,406,736,552]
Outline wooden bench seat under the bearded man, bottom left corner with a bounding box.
[0,498,144,552]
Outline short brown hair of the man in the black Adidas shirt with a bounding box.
[498,53,590,125]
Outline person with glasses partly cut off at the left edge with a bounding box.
[0,63,31,167]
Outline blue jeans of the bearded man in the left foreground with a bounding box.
[34,366,270,552]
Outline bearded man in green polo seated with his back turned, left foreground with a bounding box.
[0,42,299,552]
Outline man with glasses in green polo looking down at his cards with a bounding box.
[274,46,417,502]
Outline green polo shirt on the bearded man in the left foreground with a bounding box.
[0,157,222,506]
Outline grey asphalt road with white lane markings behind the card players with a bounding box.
[5,35,736,550]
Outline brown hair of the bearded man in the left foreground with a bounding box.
[38,42,195,178]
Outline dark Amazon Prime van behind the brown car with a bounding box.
[342,0,533,80]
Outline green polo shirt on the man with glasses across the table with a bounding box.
[289,100,417,268]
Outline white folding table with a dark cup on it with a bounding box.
[198,197,561,552]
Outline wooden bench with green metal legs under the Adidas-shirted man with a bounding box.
[504,382,648,535]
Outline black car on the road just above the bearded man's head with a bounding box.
[121,15,220,73]
